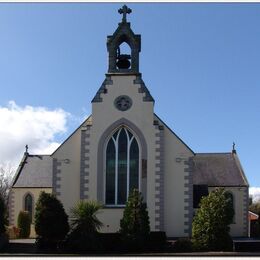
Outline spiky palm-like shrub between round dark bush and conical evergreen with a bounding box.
[64,201,103,252]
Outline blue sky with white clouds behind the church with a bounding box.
[0,3,260,198]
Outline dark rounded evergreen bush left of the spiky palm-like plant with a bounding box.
[35,192,69,248]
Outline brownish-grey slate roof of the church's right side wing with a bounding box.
[193,153,249,187]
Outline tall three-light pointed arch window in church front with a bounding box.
[105,127,140,206]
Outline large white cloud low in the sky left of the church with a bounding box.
[0,101,70,174]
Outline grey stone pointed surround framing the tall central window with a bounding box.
[97,118,147,203]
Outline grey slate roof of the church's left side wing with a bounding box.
[12,153,52,188]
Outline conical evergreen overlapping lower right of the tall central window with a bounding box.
[120,189,150,248]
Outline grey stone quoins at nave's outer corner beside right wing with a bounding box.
[184,157,193,236]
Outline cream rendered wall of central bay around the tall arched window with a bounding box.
[89,75,155,232]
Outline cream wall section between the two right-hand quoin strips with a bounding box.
[164,124,193,237]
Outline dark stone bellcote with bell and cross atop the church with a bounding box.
[107,5,141,74]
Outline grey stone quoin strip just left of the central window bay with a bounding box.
[80,126,91,200]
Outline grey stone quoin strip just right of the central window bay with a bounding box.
[154,123,164,231]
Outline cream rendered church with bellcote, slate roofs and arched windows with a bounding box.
[9,5,249,238]
